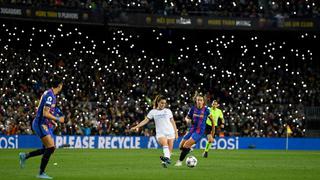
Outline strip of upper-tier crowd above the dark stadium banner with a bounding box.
[0,0,320,18]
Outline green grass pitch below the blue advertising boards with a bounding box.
[0,149,320,180]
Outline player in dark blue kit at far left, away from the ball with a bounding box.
[19,76,64,179]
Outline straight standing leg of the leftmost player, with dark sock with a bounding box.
[38,134,55,179]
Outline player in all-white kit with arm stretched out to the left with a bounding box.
[131,95,178,168]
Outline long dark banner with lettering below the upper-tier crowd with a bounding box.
[0,6,320,30]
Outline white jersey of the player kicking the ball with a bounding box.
[147,108,175,135]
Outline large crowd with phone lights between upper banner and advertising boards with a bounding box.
[0,21,320,137]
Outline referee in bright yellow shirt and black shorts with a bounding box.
[203,100,224,158]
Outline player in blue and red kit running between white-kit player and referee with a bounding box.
[175,93,215,166]
